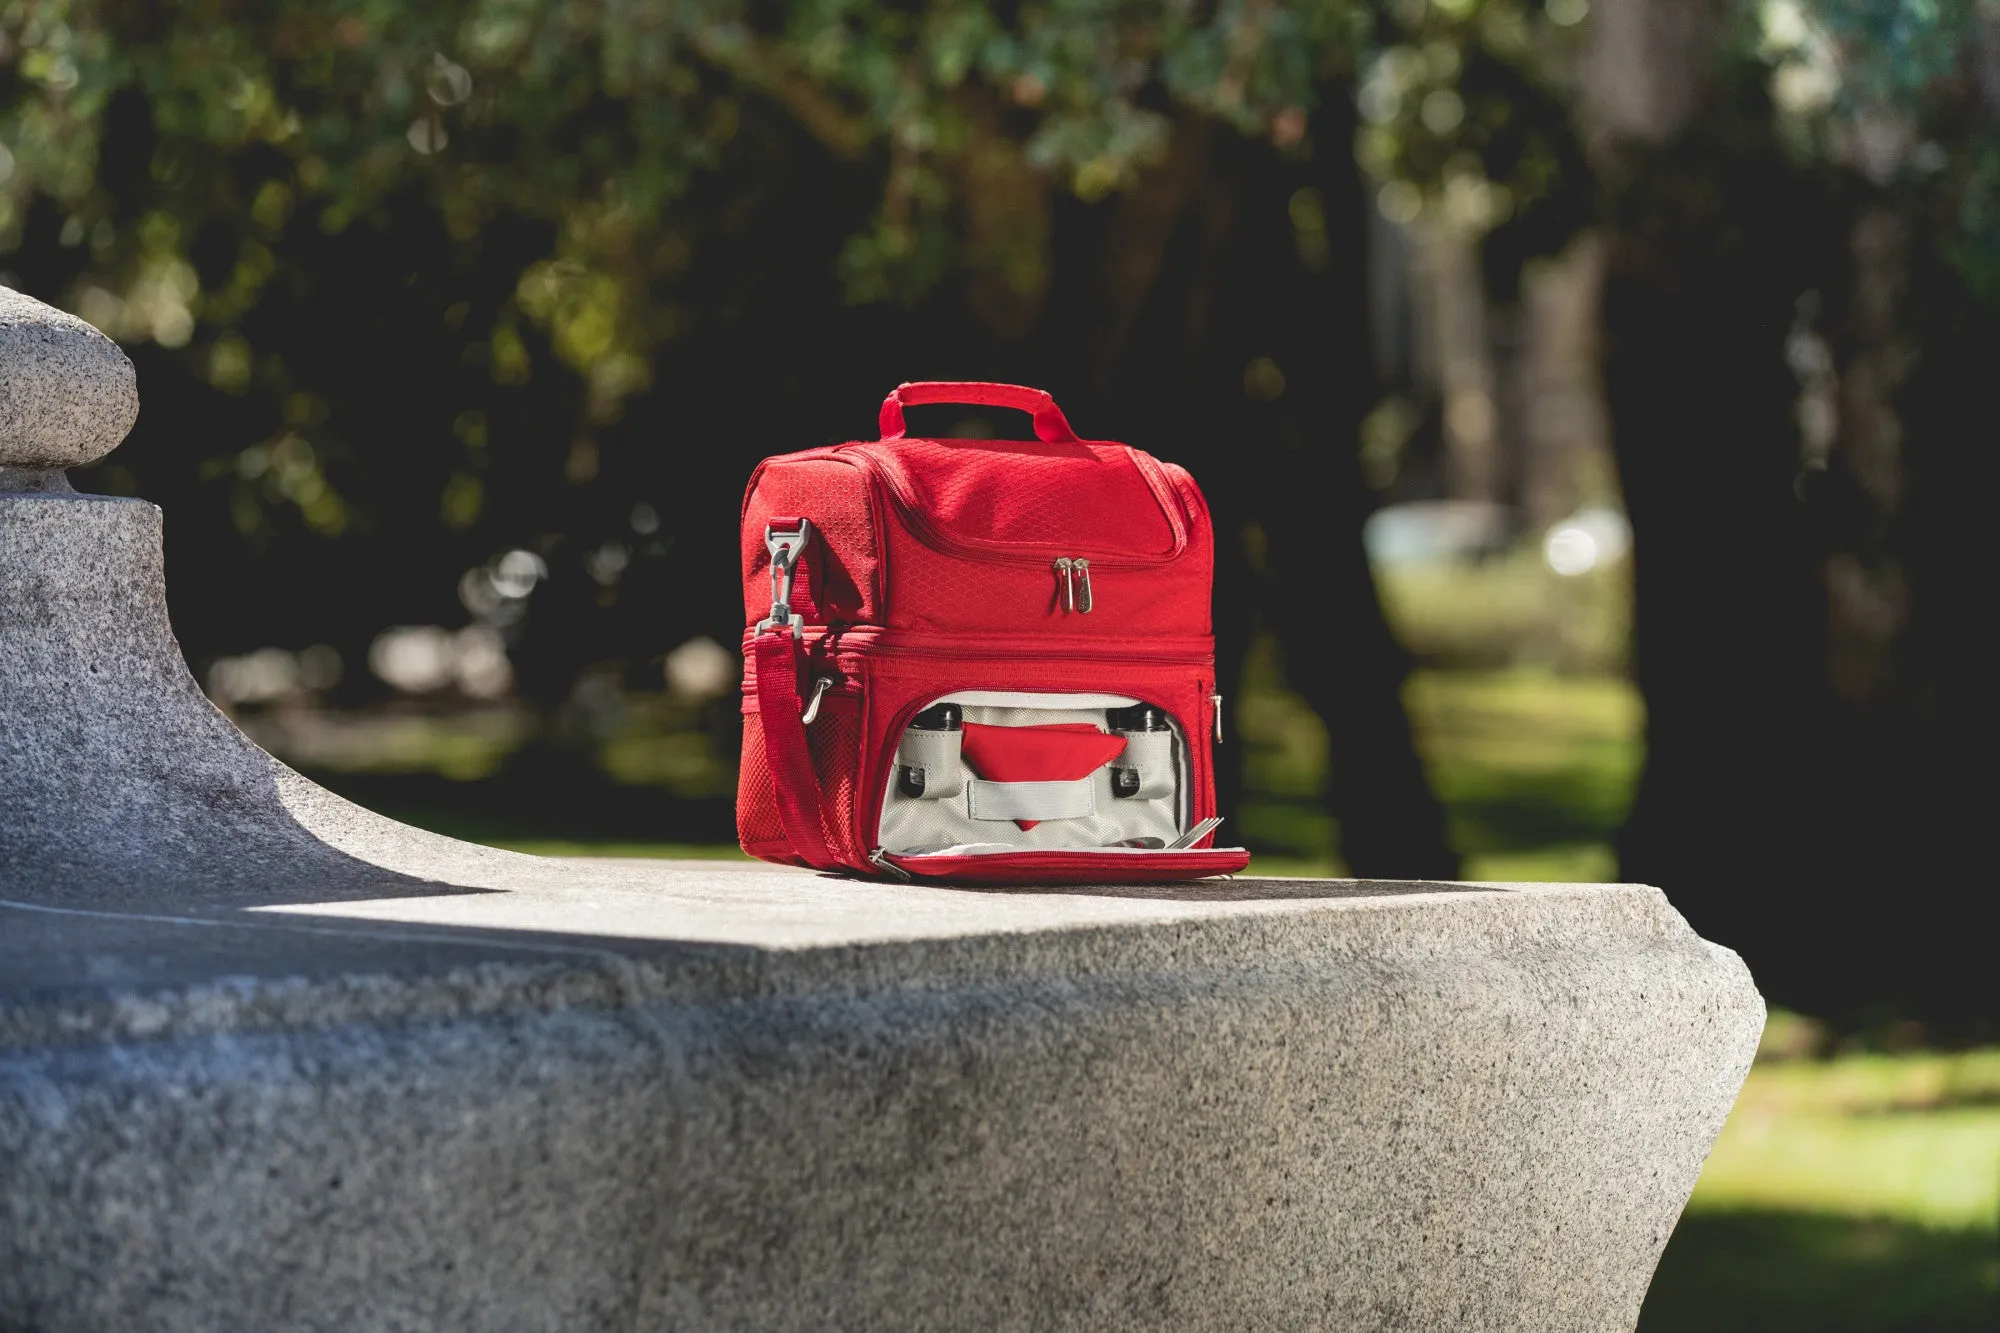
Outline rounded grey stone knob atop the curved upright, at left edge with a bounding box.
[0,286,138,468]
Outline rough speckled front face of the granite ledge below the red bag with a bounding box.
[0,879,1762,1331]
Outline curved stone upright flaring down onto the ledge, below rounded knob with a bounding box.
[0,492,548,903]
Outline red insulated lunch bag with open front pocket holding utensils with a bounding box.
[736,382,1250,885]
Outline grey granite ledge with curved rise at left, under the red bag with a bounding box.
[0,290,1762,1331]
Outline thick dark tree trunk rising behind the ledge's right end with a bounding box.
[1584,0,1822,993]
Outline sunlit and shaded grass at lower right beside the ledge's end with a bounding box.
[1640,1051,2000,1333]
